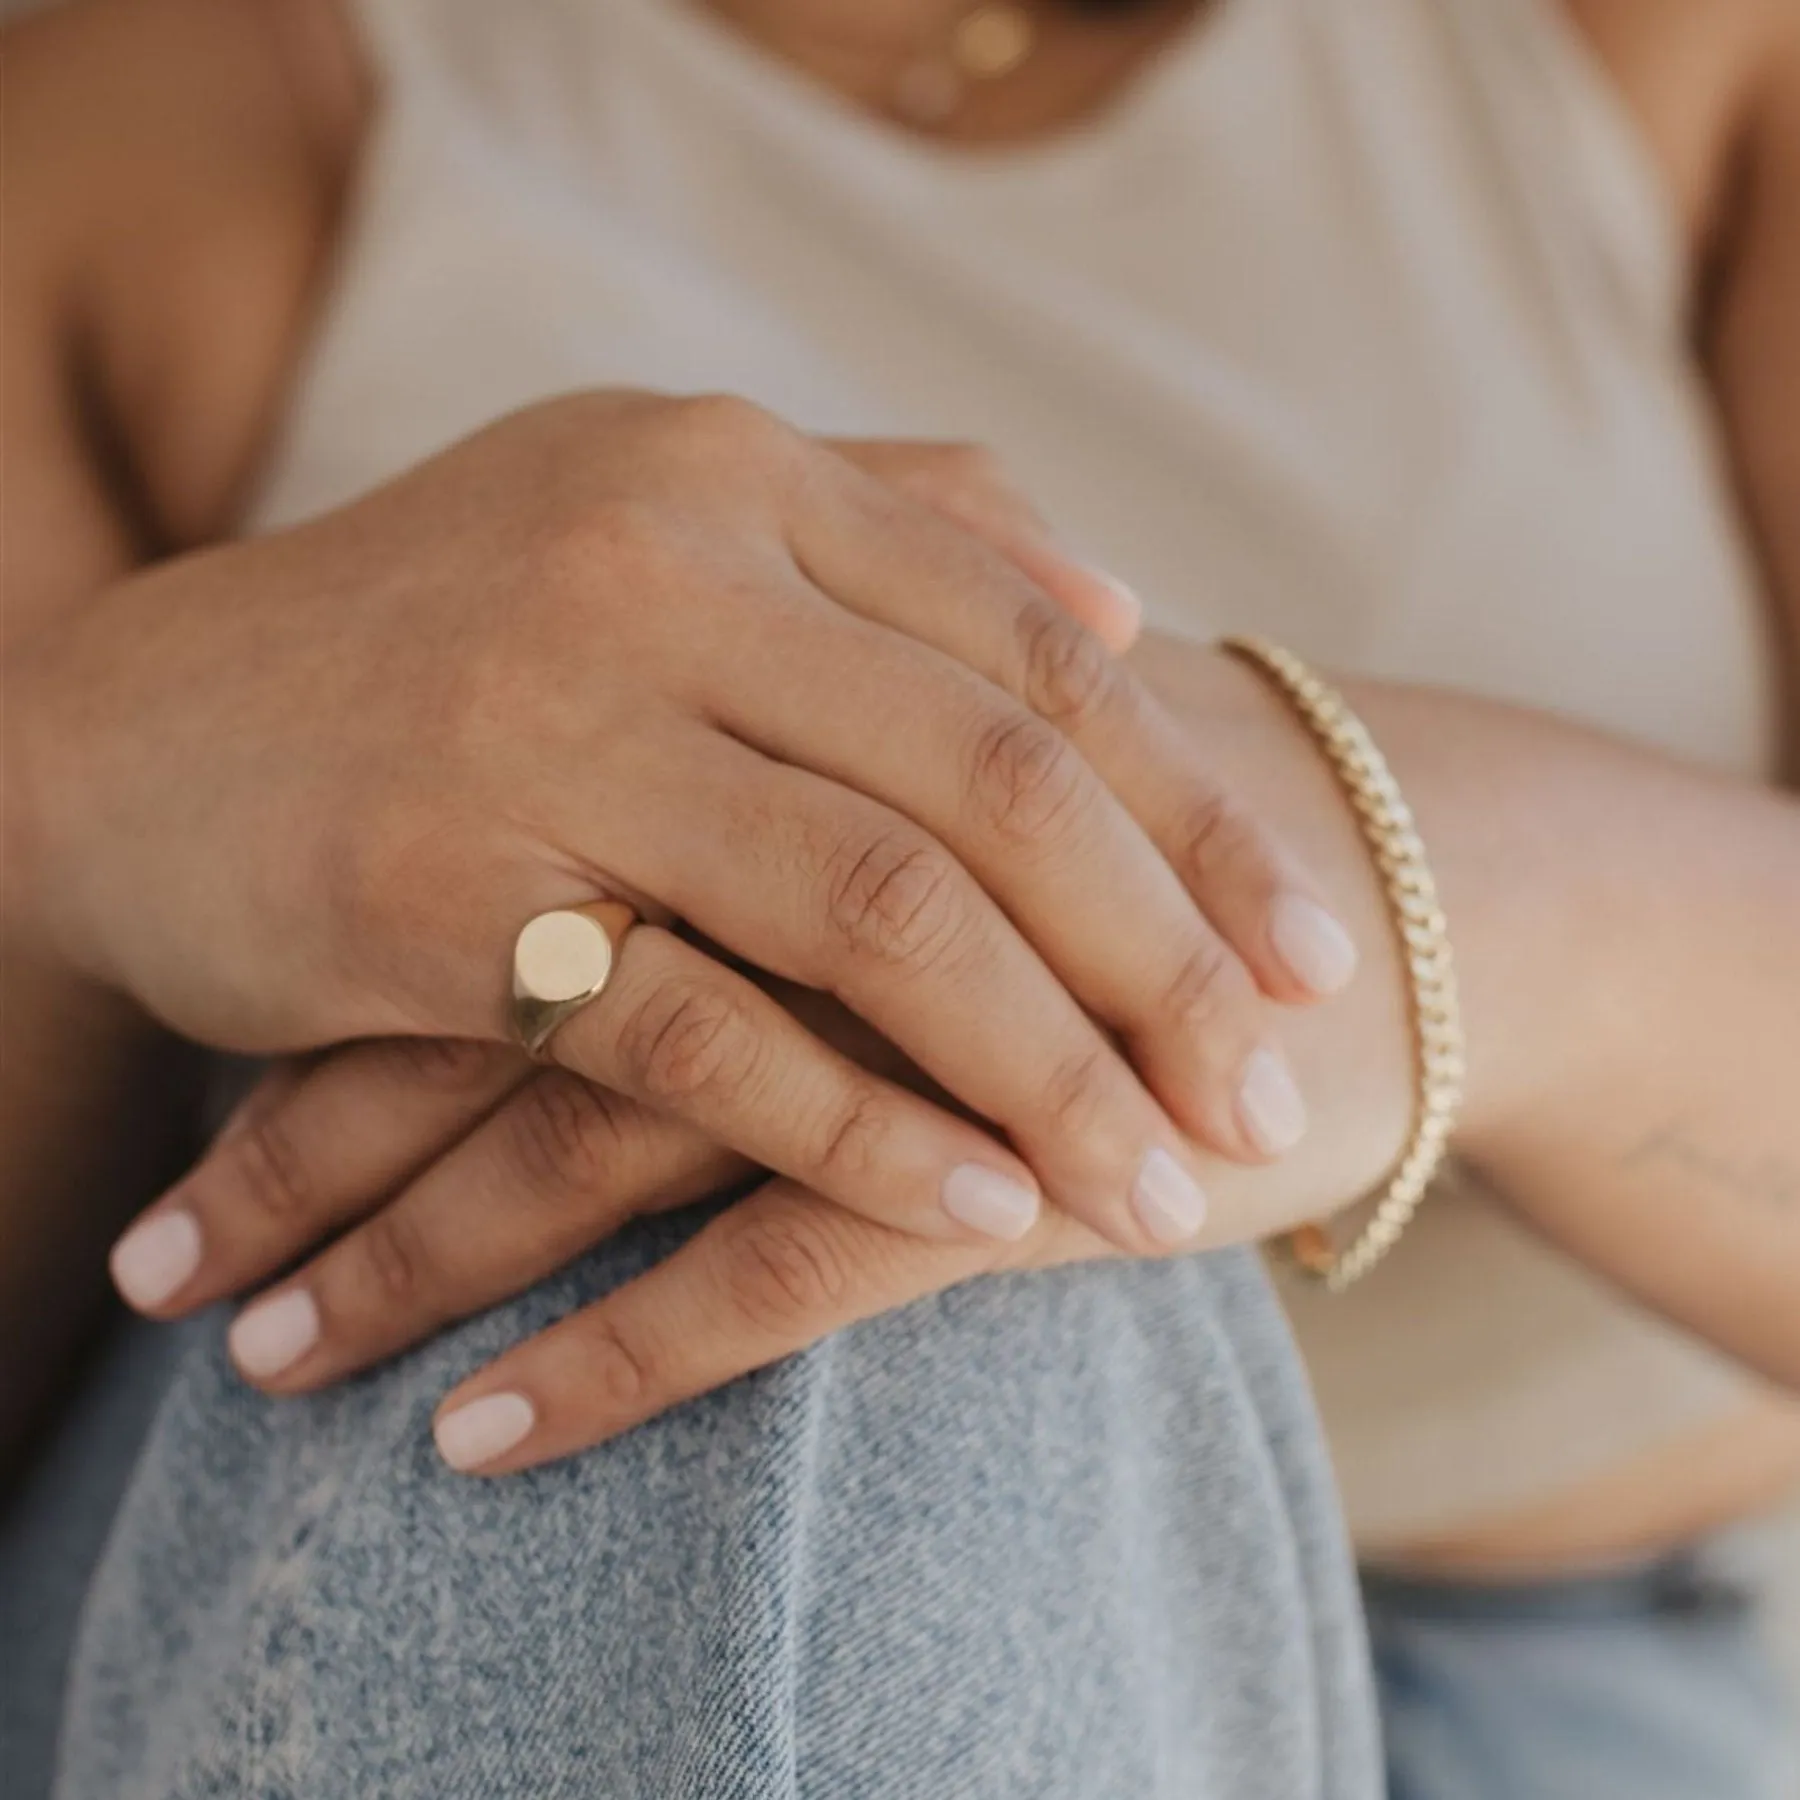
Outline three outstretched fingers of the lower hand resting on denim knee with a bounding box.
[130,995,1116,1474]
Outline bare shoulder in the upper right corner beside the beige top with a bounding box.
[1562,0,1800,261]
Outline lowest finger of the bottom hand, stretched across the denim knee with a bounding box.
[432,1181,1021,1474]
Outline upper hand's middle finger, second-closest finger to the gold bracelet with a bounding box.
[709,603,1305,1161]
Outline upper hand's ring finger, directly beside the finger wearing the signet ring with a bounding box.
[615,745,1204,1255]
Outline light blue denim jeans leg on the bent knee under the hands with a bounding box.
[0,1219,1381,1800]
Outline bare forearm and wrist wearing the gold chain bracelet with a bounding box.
[1147,643,1800,1382]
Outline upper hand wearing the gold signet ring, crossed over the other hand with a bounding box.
[14,396,1353,1253]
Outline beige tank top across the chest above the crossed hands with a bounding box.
[246,9,1777,770]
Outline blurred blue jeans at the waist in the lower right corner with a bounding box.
[1366,1553,1800,1800]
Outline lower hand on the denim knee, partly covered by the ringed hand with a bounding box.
[105,626,1413,1474]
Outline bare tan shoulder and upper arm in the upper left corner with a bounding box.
[0,0,369,544]
